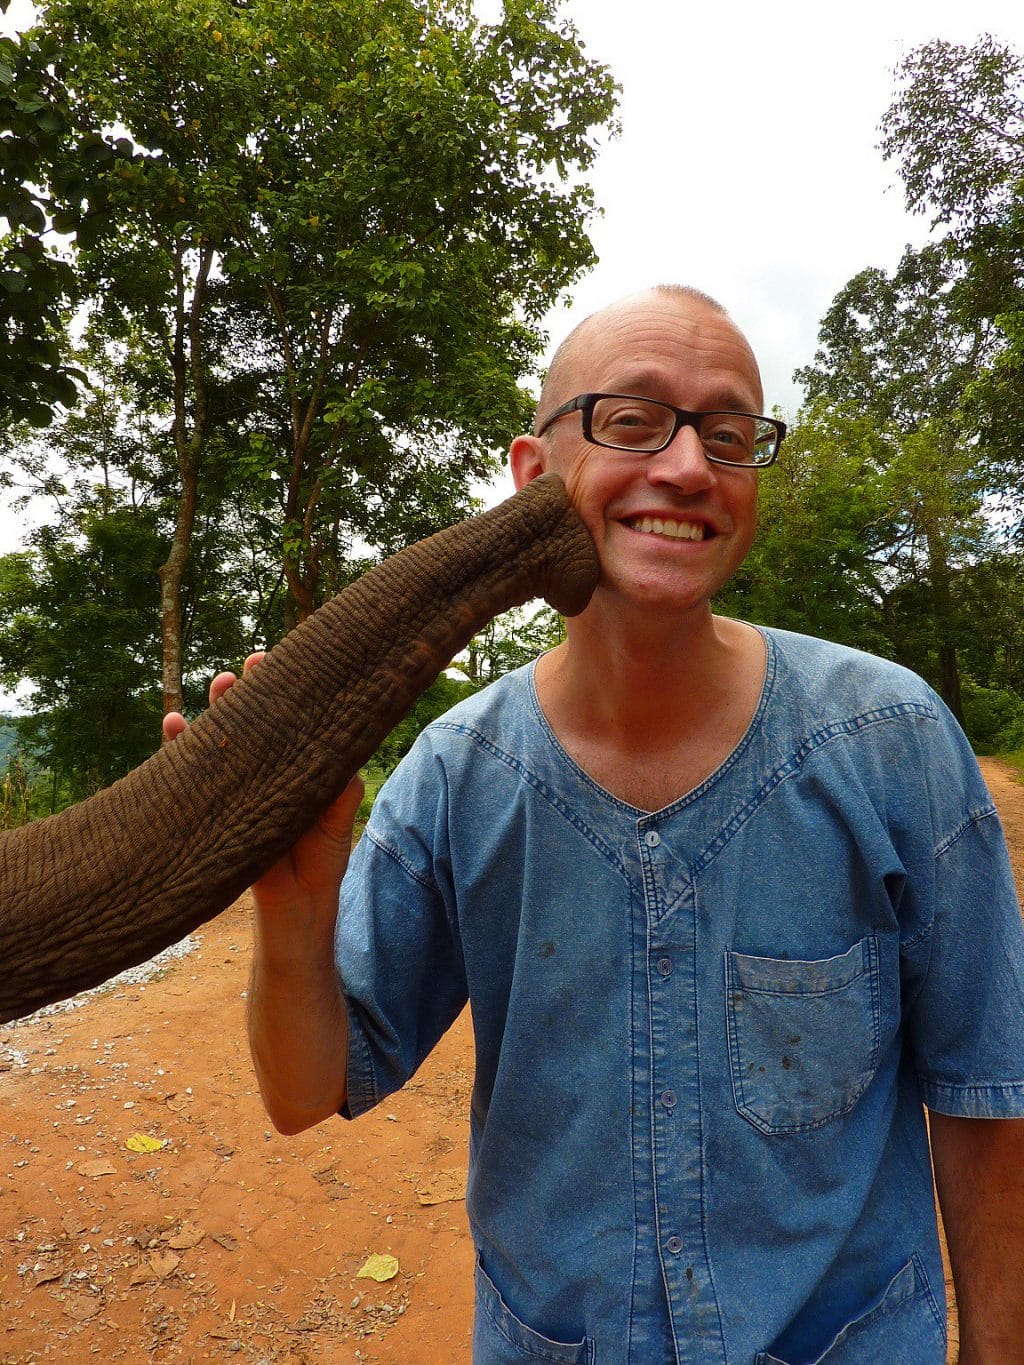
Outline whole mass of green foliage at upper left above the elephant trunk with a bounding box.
[0,0,616,753]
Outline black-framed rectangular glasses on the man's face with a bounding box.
[537,393,786,470]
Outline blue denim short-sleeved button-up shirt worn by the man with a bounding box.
[337,631,1024,1365]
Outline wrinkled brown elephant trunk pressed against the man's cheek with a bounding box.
[0,475,598,1022]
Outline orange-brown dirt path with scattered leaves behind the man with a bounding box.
[0,760,1024,1365]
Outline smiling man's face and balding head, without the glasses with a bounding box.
[512,293,763,614]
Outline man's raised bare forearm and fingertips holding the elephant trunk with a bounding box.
[164,652,363,1133]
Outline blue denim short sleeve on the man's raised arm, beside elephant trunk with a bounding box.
[335,751,467,1118]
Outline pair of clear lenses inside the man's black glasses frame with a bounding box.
[590,397,778,464]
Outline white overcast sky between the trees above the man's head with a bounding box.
[0,0,1024,521]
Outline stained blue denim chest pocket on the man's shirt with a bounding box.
[725,935,881,1133]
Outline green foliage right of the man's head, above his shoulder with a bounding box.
[724,38,1024,748]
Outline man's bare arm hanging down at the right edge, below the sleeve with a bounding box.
[928,1111,1024,1365]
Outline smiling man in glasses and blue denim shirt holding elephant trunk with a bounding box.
[176,288,1024,1365]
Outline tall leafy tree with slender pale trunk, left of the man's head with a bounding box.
[20,0,614,708]
